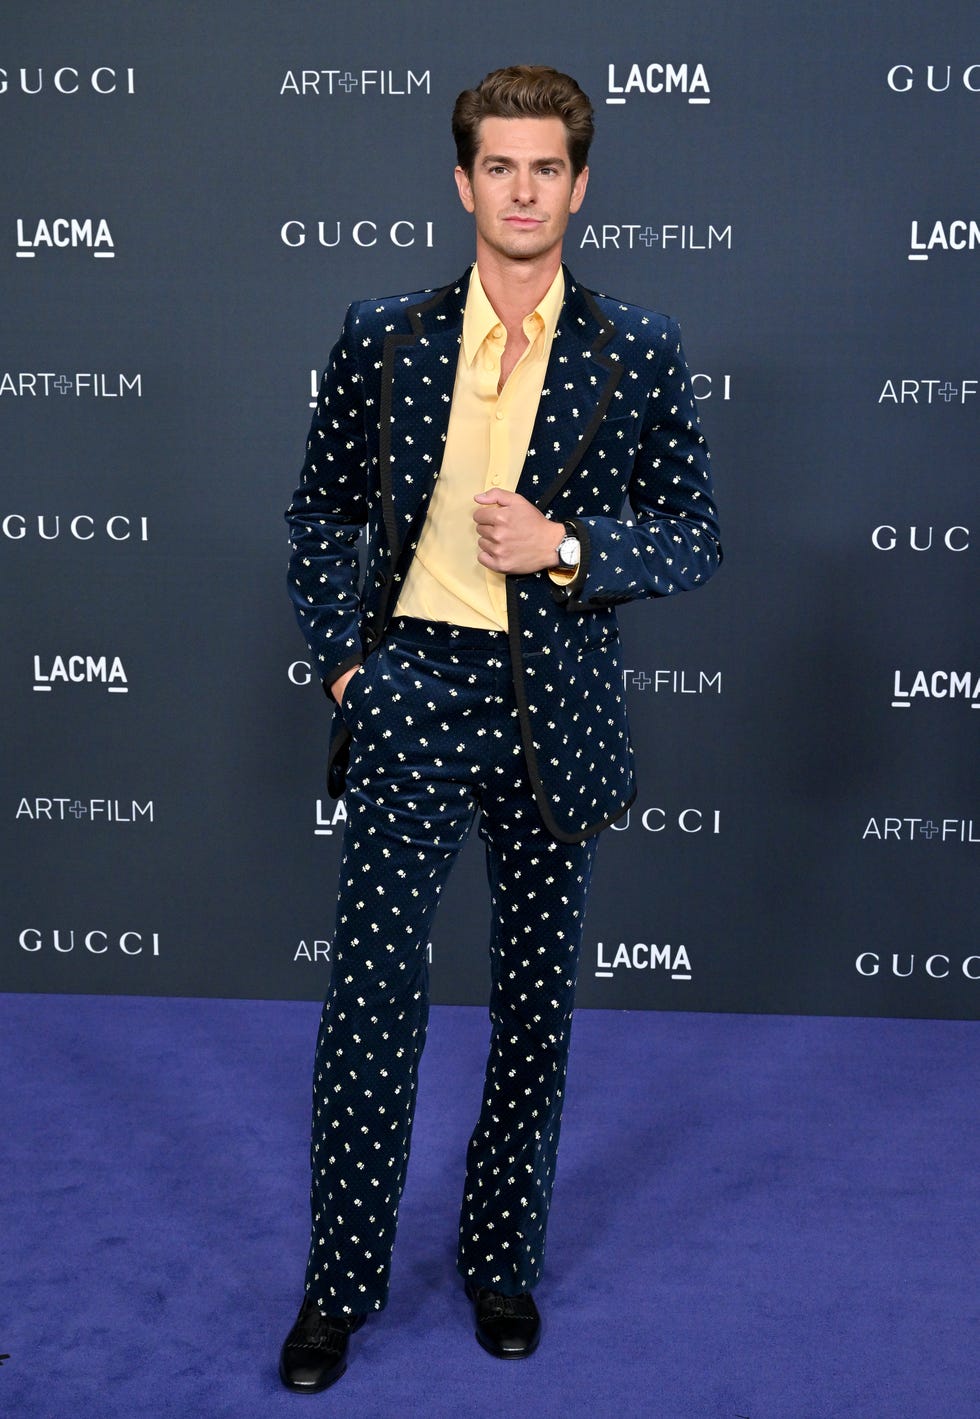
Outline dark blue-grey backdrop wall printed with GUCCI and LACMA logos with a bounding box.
[0,0,980,1017]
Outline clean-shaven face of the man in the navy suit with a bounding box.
[455,118,589,261]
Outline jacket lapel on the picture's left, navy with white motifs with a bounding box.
[380,271,469,565]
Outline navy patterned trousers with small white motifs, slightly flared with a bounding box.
[306,617,596,1315]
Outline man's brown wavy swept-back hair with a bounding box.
[452,64,596,177]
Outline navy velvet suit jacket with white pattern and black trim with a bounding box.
[286,268,720,841]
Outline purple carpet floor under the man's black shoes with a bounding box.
[0,996,980,1419]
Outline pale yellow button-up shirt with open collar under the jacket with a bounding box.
[399,267,564,630]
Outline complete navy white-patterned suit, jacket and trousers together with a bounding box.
[286,270,720,1314]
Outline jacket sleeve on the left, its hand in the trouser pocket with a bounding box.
[286,305,367,692]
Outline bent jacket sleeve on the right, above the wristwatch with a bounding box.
[552,321,722,612]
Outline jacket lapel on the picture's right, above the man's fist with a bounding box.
[518,267,623,509]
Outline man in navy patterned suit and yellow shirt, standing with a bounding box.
[279,65,720,1391]
